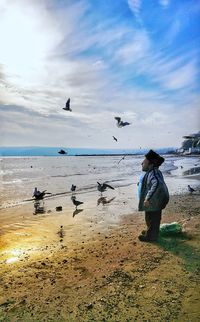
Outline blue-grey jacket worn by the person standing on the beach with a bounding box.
[138,168,169,211]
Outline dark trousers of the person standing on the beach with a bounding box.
[145,210,162,240]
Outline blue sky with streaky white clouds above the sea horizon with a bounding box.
[0,0,200,149]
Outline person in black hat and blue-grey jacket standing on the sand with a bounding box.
[138,150,169,242]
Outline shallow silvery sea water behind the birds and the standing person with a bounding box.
[0,155,200,208]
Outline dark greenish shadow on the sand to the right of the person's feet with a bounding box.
[158,232,200,273]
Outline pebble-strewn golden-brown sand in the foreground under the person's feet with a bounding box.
[0,193,200,322]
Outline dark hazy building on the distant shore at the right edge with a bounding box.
[177,131,200,154]
